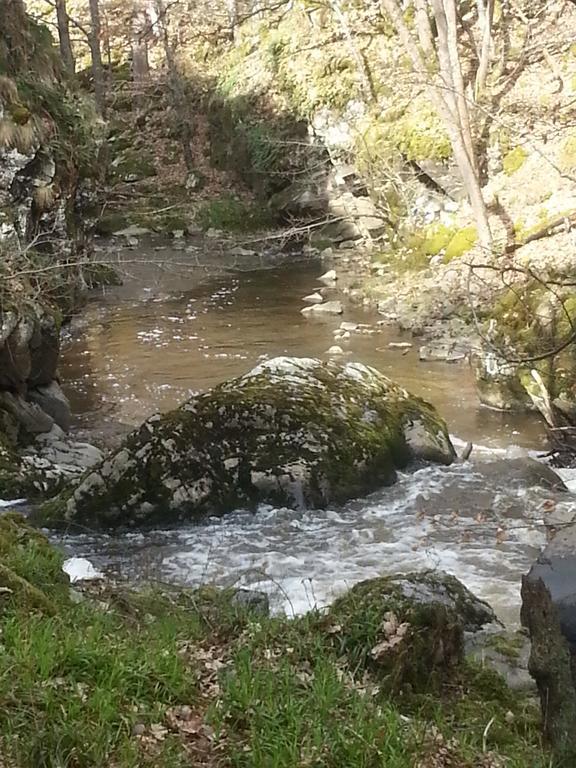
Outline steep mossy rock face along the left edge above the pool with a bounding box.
[0,0,98,496]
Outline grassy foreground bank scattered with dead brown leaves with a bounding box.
[0,516,551,768]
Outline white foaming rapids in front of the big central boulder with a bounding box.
[53,462,575,622]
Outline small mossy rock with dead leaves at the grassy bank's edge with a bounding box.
[327,571,496,691]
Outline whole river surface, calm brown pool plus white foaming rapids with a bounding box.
[53,243,574,621]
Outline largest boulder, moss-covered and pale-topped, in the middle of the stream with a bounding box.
[40,358,455,527]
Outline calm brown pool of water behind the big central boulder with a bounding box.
[60,246,543,447]
